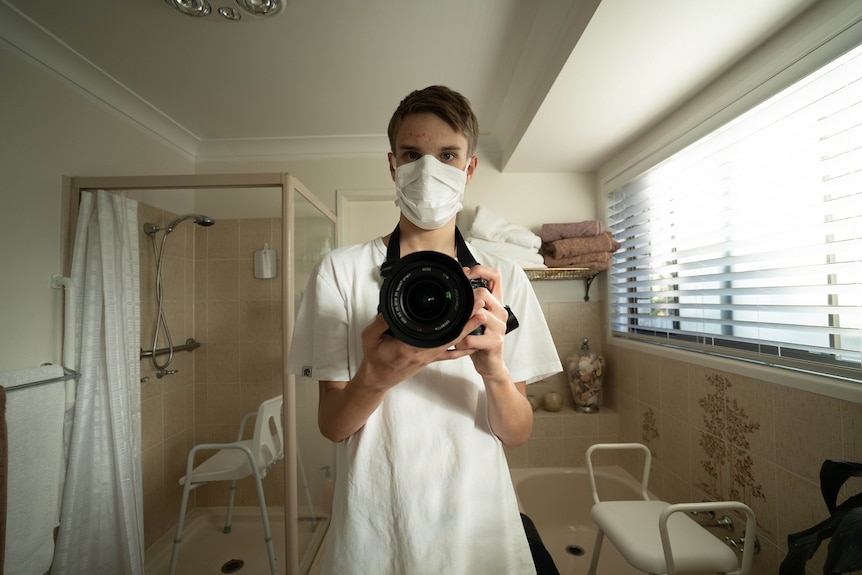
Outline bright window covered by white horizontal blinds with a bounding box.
[608,42,862,382]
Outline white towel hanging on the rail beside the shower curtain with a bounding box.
[0,365,66,575]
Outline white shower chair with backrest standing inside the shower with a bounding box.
[170,395,284,575]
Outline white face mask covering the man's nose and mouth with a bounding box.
[393,155,470,230]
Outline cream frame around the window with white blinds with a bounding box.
[598,2,862,403]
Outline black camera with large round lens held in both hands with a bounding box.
[378,251,488,347]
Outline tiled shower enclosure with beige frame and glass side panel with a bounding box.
[66,173,335,574]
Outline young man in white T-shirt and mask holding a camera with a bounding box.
[289,86,562,575]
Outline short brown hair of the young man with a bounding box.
[388,86,479,157]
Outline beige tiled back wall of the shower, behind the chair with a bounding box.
[194,218,284,507]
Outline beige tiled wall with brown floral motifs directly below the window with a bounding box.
[608,343,862,573]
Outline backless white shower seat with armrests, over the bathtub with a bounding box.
[586,443,756,575]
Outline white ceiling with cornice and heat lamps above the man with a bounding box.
[0,0,815,172]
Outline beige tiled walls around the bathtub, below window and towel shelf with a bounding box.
[506,292,862,573]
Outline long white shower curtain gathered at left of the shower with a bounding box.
[51,190,144,575]
